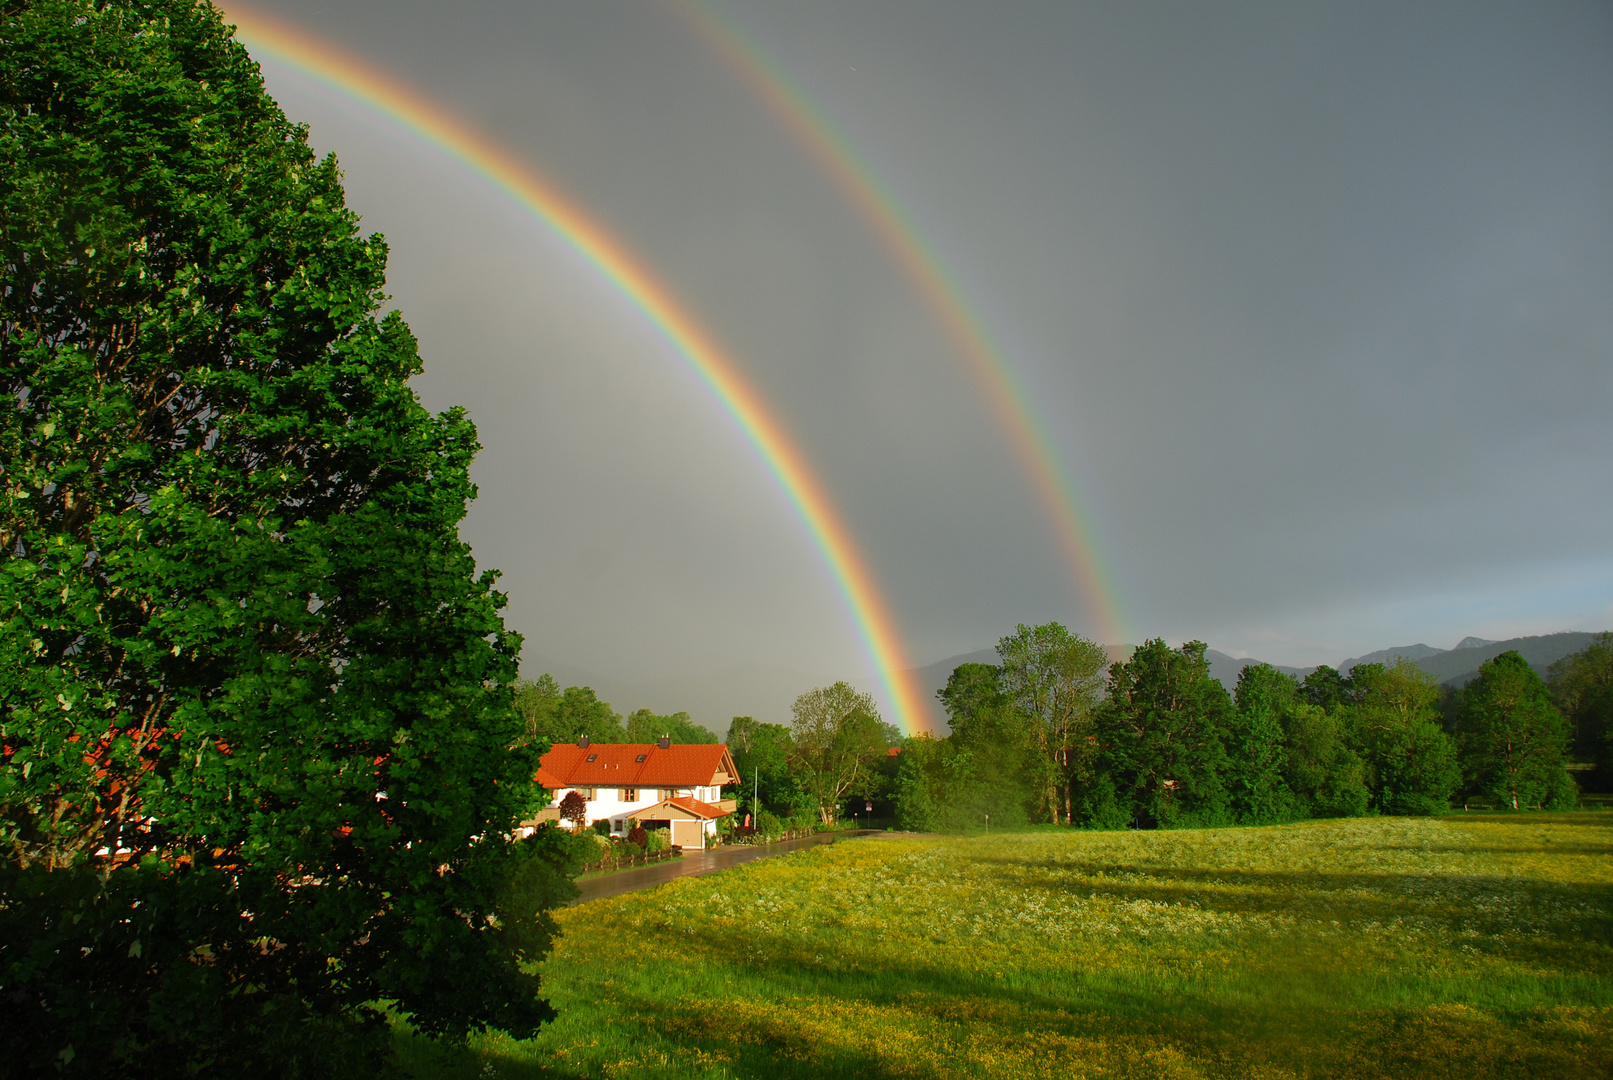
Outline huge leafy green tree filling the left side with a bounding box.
[0,0,571,1077]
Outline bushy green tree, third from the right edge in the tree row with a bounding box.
[1337,659,1461,814]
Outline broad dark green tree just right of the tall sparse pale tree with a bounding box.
[1082,638,1232,827]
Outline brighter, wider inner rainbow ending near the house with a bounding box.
[223,2,929,733]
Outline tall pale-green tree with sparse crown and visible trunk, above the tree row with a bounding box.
[997,622,1108,825]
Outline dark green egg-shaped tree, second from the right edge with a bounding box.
[1457,651,1579,809]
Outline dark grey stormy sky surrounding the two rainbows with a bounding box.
[224,0,1613,719]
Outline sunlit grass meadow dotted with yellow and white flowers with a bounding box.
[398,812,1613,1080]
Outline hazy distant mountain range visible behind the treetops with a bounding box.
[523,630,1597,737]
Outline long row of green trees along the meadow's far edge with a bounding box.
[897,624,1613,830]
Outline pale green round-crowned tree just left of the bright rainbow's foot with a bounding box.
[789,682,890,825]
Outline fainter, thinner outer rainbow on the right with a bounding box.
[669,0,1127,645]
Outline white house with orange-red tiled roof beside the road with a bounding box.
[537,738,739,848]
